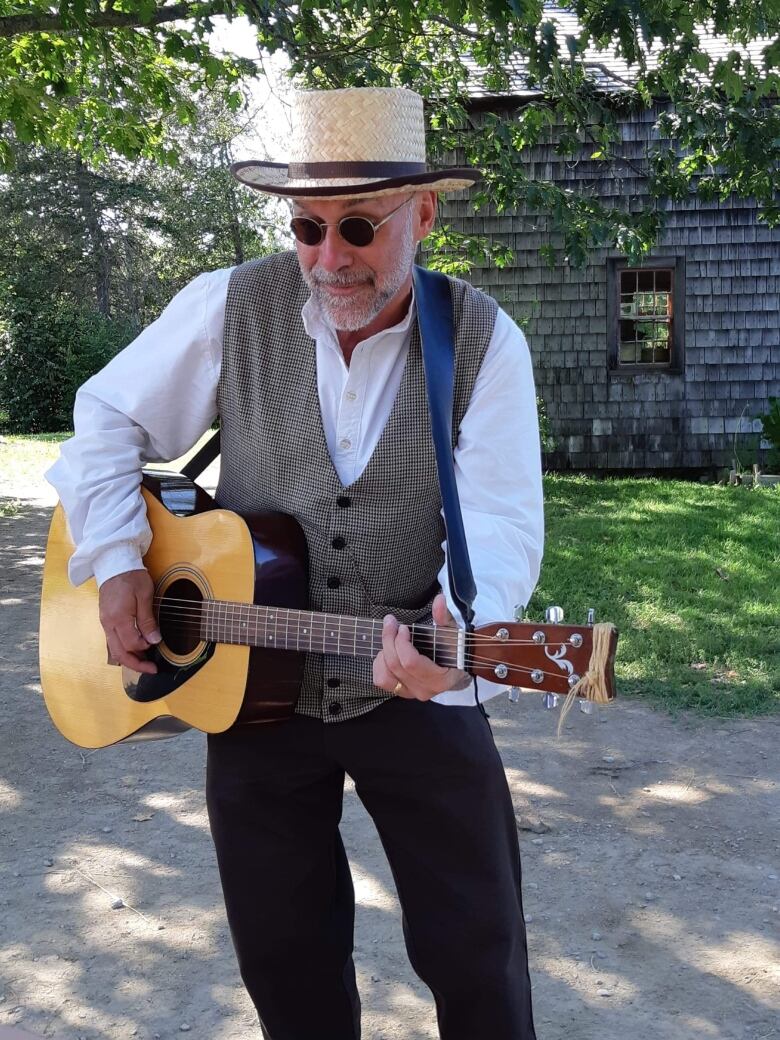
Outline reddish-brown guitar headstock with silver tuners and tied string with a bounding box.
[468,607,618,707]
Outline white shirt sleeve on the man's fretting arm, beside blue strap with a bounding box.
[435,310,544,704]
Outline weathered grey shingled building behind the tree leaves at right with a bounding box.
[444,6,780,472]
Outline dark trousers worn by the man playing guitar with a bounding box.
[207,699,536,1040]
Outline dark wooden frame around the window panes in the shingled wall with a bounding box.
[606,256,685,375]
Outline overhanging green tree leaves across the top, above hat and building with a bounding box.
[0,0,780,269]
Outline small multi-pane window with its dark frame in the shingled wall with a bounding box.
[607,257,684,372]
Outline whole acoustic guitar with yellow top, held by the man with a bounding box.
[41,472,618,748]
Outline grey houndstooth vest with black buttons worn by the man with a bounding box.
[216,253,496,722]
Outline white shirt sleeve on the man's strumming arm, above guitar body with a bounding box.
[46,269,231,586]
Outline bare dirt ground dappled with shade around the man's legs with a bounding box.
[0,463,780,1040]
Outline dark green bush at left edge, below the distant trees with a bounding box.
[0,297,133,434]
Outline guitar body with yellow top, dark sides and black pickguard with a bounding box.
[41,473,308,748]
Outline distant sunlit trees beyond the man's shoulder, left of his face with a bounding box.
[0,96,284,329]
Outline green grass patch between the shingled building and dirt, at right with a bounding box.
[529,475,780,716]
